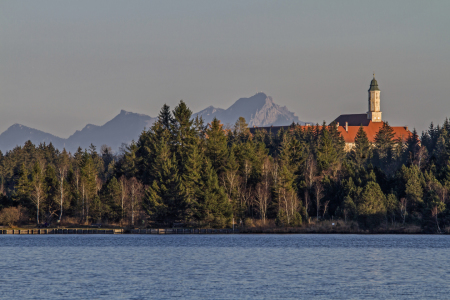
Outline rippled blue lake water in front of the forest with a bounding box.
[0,234,450,299]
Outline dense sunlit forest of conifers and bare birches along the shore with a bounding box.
[0,101,450,232]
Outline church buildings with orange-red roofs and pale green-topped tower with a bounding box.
[250,74,411,151]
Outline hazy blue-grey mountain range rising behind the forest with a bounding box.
[0,93,304,153]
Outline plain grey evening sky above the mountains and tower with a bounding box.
[0,0,450,138]
